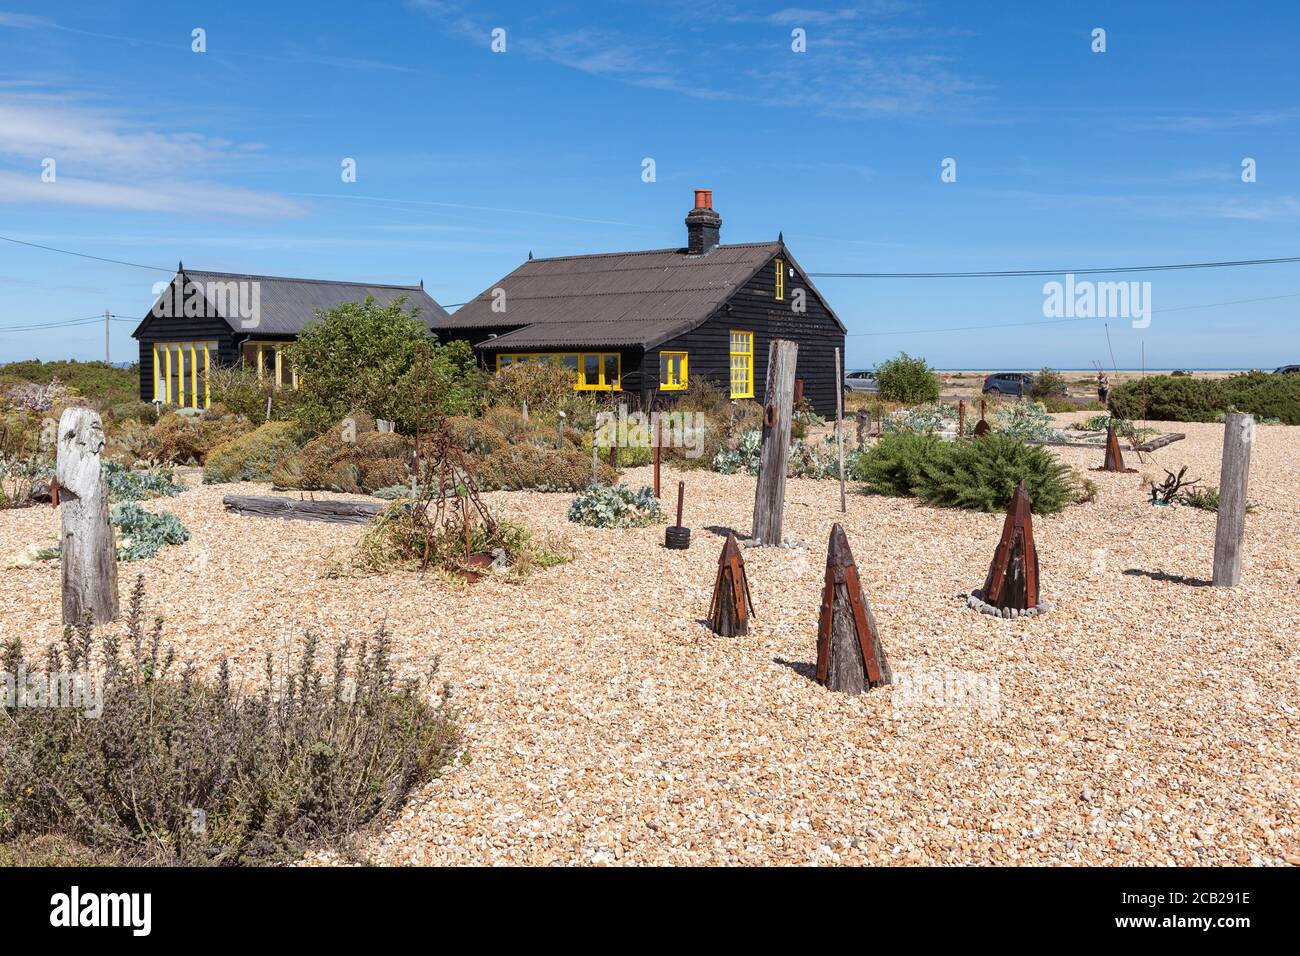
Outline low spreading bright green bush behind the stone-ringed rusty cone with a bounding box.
[850,432,1080,514]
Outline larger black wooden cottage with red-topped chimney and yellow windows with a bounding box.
[434,190,845,415]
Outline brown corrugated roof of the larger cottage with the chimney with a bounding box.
[436,242,783,351]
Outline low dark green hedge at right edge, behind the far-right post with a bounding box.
[1109,372,1300,425]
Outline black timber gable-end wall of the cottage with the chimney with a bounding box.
[644,256,844,418]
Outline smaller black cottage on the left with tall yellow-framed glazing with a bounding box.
[131,264,447,408]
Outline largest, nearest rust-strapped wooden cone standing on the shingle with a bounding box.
[816,524,893,693]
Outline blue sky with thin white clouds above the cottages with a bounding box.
[0,0,1300,368]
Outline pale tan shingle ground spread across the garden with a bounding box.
[0,415,1300,865]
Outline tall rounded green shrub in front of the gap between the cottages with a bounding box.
[285,298,484,434]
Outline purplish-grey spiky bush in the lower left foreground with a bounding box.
[0,581,458,865]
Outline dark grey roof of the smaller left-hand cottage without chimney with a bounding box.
[137,269,449,336]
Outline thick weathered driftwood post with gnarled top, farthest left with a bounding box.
[55,408,117,624]
